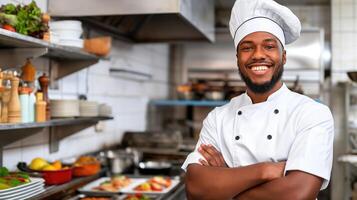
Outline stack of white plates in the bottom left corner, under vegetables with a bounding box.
[0,178,45,200]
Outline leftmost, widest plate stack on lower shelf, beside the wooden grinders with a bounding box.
[50,99,79,117]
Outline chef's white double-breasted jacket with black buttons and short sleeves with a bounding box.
[182,84,334,189]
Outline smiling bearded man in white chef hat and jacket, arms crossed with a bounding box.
[182,0,334,200]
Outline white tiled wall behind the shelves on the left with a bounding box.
[0,0,169,169]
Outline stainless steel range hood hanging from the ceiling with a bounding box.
[48,0,215,42]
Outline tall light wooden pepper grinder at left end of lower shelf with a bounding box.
[8,74,21,123]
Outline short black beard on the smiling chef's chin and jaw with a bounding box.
[238,64,284,94]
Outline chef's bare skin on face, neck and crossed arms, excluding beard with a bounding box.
[186,32,323,200]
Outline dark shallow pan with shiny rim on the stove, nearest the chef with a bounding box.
[138,161,172,175]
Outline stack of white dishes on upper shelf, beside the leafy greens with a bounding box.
[50,20,83,48]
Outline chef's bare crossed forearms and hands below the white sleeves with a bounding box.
[186,145,322,200]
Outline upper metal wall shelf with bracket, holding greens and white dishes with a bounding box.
[0,29,100,80]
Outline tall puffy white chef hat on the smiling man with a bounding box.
[229,0,301,48]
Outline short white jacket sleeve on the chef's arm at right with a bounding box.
[285,102,334,190]
